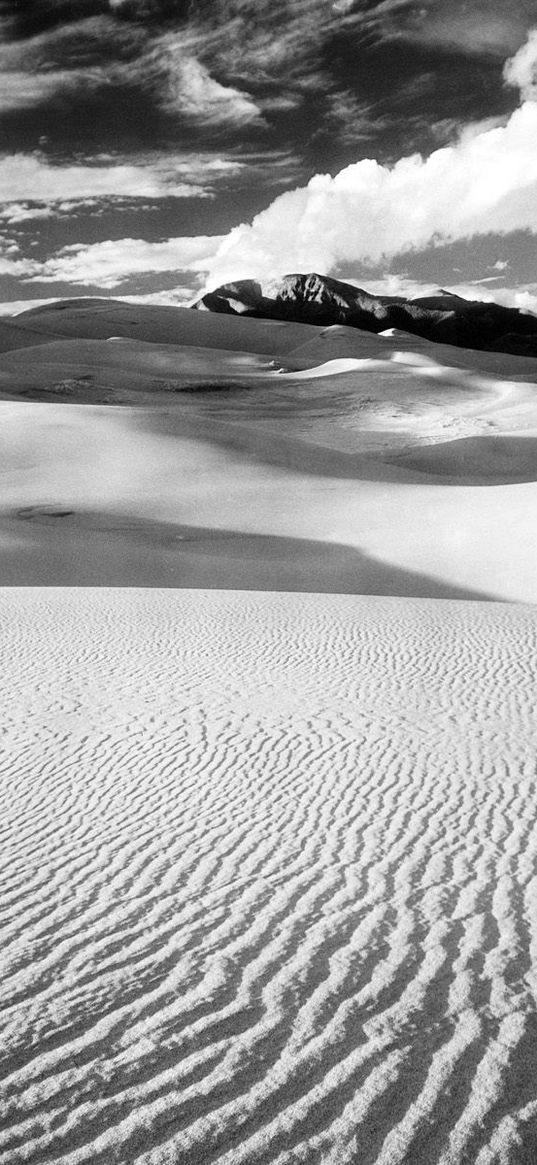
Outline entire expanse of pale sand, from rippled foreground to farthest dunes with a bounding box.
[0,304,537,1165]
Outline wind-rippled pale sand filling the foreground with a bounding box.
[0,588,537,1165]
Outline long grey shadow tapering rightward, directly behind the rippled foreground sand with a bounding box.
[0,506,495,600]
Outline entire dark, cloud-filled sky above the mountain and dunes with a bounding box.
[0,0,537,311]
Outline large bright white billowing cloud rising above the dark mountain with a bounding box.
[195,92,537,287]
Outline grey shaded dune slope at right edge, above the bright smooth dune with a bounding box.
[139,410,537,486]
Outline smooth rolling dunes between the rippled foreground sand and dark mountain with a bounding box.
[0,302,537,602]
